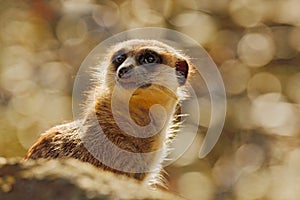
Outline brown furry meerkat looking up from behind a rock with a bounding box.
[25,39,192,187]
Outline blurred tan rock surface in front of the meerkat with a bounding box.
[0,158,181,200]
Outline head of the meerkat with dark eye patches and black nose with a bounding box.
[105,39,189,98]
